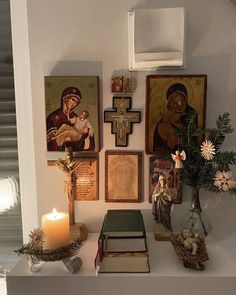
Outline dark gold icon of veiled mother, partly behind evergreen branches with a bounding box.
[145,75,207,155]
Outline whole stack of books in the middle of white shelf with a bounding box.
[95,210,150,273]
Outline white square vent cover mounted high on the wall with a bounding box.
[128,7,185,71]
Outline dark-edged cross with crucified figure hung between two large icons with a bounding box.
[104,96,141,146]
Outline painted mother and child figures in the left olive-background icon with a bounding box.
[47,87,95,151]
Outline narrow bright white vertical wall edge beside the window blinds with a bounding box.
[10,0,38,240]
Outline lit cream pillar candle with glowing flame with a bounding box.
[42,209,69,249]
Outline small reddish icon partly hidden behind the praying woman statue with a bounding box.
[149,155,183,204]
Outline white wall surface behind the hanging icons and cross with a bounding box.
[11,0,236,247]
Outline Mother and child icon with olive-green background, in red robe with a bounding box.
[44,76,100,159]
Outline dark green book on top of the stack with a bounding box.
[101,209,146,237]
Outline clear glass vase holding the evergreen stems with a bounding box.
[183,188,212,237]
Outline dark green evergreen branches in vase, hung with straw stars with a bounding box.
[176,113,236,194]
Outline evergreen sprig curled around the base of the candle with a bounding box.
[15,240,82,263]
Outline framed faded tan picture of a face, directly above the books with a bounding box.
[105,151,143,203]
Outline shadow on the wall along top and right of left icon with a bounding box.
[44,61,103,149]
